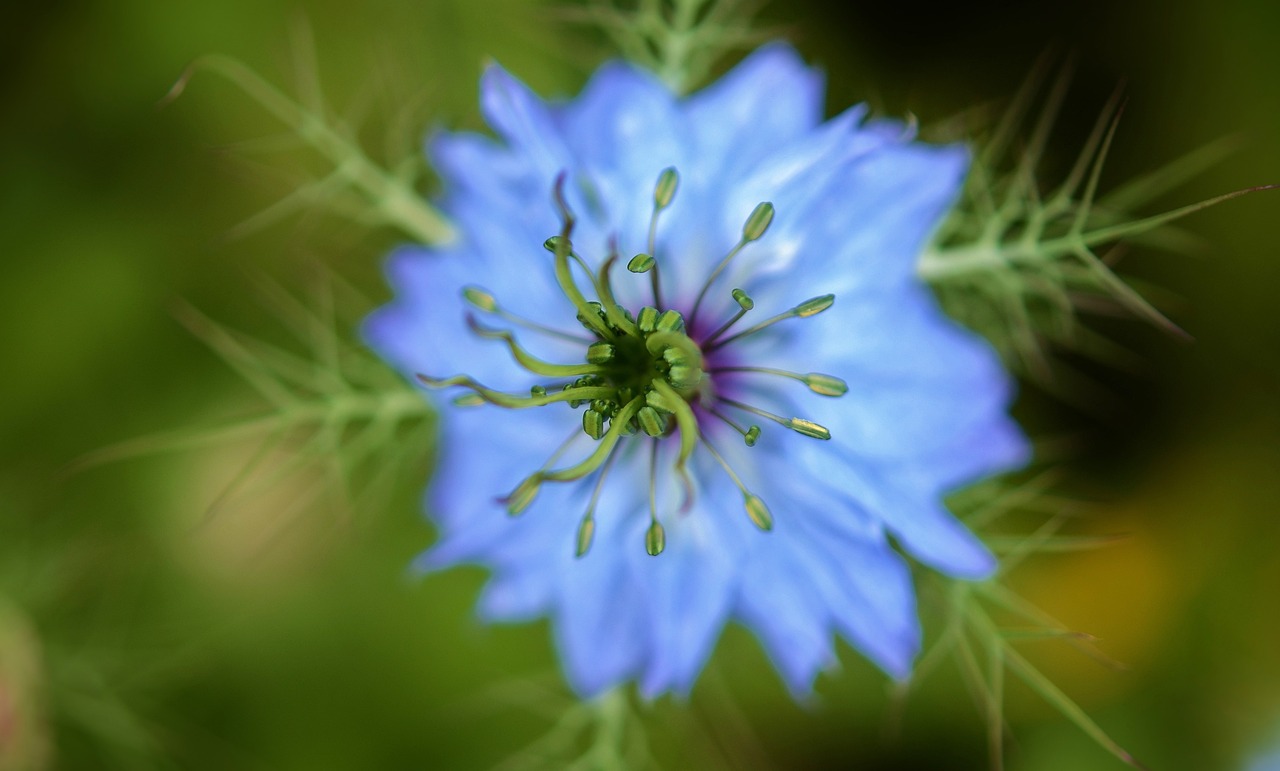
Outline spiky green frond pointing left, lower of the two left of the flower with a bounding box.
[79,272,434,530]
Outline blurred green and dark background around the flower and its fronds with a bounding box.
[0,0,1280,771]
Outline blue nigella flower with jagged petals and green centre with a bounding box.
[365,45,1025,695]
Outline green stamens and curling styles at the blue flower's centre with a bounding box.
[419,169,847,556]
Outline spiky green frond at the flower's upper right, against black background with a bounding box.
[919,58,1271,391]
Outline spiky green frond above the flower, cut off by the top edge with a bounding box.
[570,0,765,93]
